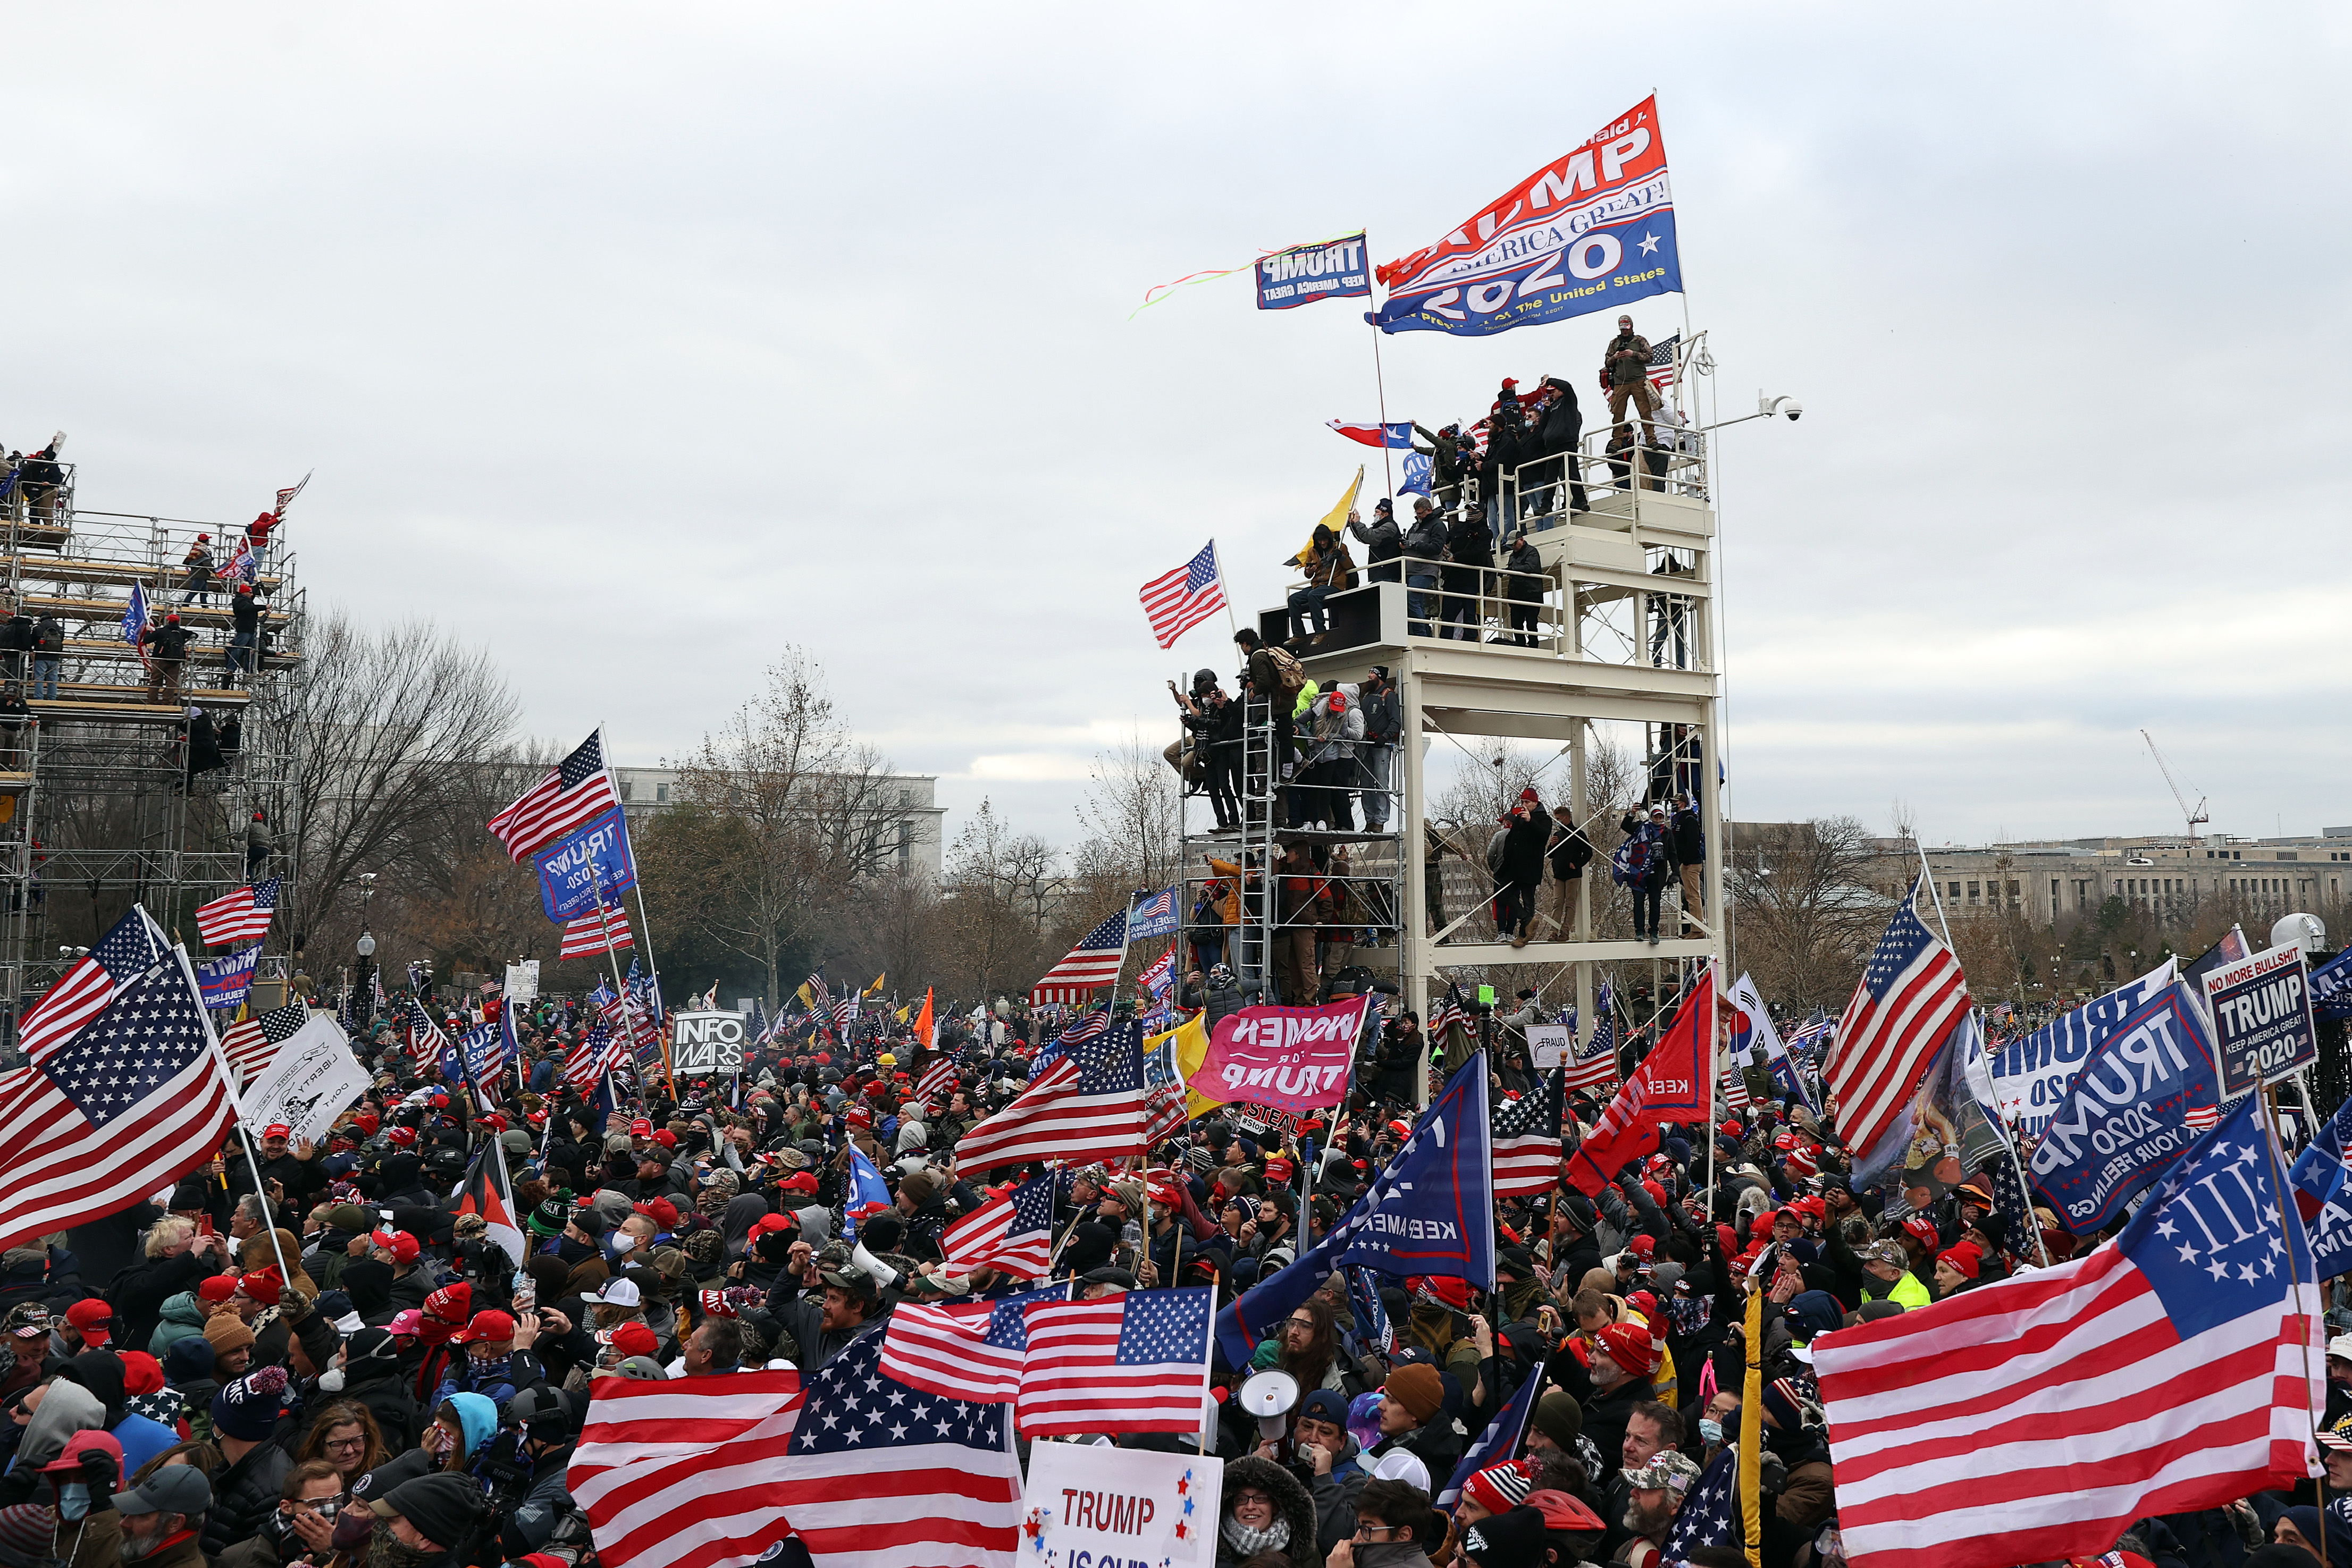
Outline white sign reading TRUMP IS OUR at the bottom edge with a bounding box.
[1021,1441,1225,1568]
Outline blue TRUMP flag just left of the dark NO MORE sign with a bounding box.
[2032,980,2220,1236]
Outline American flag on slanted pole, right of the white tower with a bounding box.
[1827,882,1969,1171]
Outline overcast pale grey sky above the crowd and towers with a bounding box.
[0,5,2352,860]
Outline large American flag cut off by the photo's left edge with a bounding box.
[0,945,238,1249]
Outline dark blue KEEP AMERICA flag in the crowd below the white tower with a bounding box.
[1216,1056,1493,1366]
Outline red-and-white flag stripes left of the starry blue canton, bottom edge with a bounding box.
[565,1370,804,1568]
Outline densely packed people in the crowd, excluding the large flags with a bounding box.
[0,964,2352,1568]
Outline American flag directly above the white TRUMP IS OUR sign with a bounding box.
[1014,1286,1216,1436]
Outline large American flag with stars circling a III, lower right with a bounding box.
[1811,1095,2326,1568]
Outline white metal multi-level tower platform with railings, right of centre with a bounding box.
[1186,416,1724,1081]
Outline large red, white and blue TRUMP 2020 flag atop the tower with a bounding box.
[1364,99,1682,336]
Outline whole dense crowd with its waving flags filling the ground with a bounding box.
[0,860,2352,1568]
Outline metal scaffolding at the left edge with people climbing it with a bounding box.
[0,466,308,1058]
